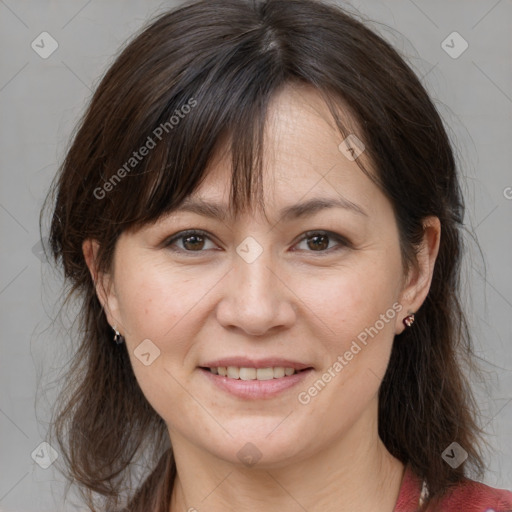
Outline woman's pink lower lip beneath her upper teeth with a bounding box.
[199,368,313,400]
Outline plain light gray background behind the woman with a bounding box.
[0,0,512,512]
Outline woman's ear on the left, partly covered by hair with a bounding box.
[82,238,124,331]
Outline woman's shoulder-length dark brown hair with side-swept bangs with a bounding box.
[42,0,483,511]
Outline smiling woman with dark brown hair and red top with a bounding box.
[44,0,512,512]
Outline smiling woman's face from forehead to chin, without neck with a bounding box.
[89,87,432,467]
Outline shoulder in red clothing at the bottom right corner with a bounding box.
[428,479,512,512]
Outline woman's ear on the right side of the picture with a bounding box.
[395,216,441,334]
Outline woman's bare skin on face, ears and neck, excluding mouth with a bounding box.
[84,86,440,512]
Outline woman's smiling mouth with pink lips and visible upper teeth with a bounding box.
[198,358,313,400]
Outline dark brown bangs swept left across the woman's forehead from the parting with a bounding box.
[107,21,293,230]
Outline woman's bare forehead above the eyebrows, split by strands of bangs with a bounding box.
[178,84,382,220]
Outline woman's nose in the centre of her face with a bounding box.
[217,248,297,336]
